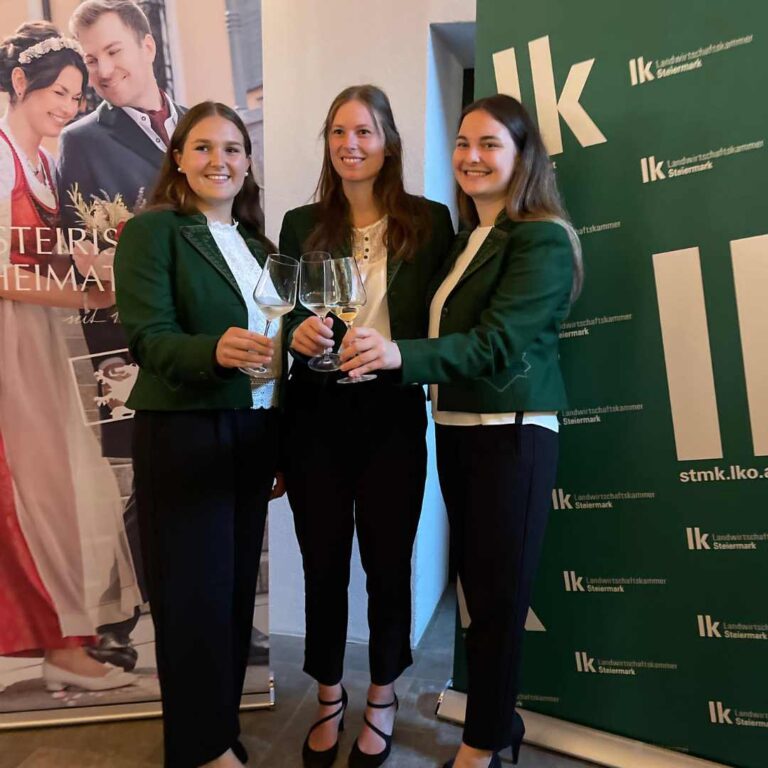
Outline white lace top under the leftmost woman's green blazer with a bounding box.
[208,221,282,408]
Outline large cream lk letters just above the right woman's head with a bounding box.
[493,35,608,155]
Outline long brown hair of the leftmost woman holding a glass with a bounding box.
[148,101,274,248]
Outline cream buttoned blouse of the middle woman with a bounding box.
[352,216,392,340]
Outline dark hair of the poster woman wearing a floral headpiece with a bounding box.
[0,21,88,104]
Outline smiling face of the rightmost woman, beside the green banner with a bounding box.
[453,110,517,211]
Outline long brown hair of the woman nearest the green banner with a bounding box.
[456,93,584,301]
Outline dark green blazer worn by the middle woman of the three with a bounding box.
[280,200,454,381]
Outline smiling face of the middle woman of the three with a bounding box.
[327,101,386,186]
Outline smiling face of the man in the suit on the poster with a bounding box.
[78,13,158,107]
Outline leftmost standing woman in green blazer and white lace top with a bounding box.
[115,102,285,768]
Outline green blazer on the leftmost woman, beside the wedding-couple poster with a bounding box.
[115,211,286,411]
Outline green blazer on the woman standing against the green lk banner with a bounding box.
[397,214,573,413]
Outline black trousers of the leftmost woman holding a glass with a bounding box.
[133,410,278,768]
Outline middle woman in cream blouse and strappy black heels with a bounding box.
[280,85,453,768]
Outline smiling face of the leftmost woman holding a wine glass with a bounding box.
[174,115,250,220]
